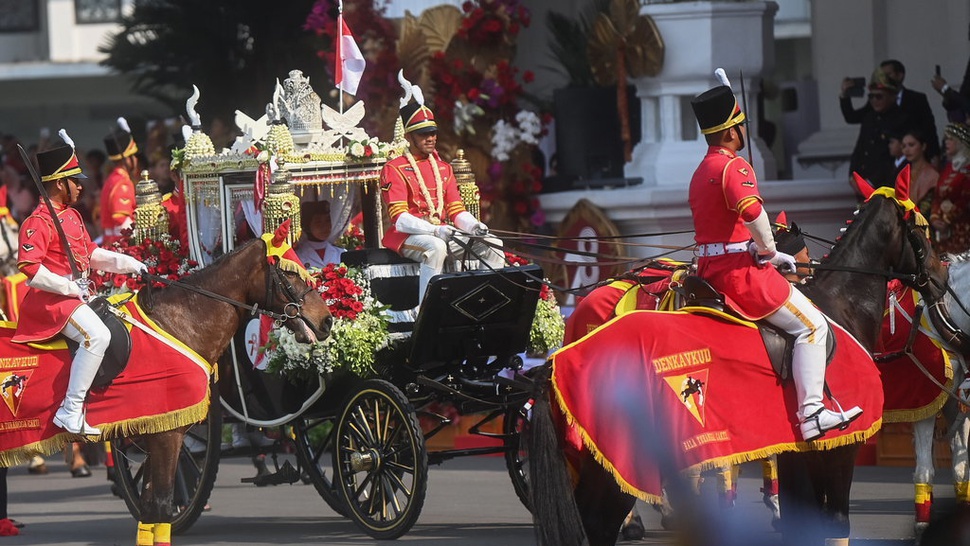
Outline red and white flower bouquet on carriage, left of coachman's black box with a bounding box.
[261,264,390,382]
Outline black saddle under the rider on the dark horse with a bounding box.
[672,275,836,381]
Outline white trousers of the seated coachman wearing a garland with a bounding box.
[401,235,505,304]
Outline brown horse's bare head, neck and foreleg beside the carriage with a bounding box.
[116,239,333,546]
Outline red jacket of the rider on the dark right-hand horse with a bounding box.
[689,146,792,320]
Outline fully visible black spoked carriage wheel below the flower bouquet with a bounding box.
[333,379,428,540]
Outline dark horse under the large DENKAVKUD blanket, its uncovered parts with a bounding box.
[530,177,947,546]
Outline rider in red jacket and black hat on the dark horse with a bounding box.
[689,78,862,441]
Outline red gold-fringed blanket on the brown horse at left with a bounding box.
[0,298,211,466]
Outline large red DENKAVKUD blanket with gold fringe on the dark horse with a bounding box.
[552,309,883,502]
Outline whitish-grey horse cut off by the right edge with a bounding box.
[913,253,970,541]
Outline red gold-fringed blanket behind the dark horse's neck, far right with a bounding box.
[878,281,955,423]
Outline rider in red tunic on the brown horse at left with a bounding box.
[13,136,146,435]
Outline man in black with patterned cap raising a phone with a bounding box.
[839,67,908,191]
